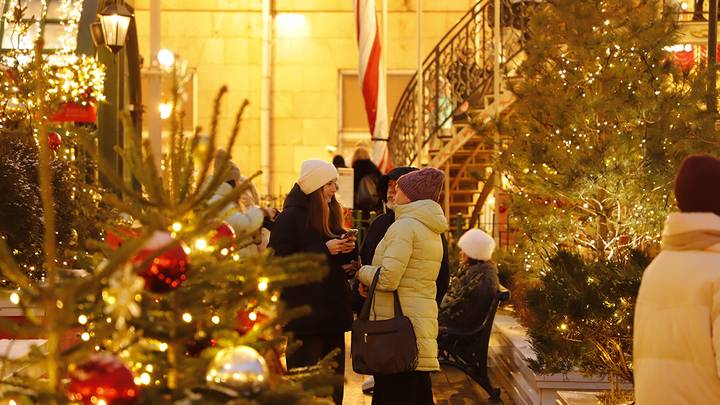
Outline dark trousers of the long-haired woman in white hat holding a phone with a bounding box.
[287,333,345,405]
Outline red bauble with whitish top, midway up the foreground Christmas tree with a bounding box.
[133,231,188,293]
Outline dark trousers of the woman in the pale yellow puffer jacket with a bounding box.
[372,371,433,405]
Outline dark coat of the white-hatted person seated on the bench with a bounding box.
[438,261,499,329]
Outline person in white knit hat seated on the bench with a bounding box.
[438,229,499,329]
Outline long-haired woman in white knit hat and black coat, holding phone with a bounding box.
[269,159,358,405]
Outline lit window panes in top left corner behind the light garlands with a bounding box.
[0,0,83,52]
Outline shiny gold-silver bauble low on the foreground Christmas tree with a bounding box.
[205,346,269,393]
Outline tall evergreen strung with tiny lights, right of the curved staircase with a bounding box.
[502,0,720,388]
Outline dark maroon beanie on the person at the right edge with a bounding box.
[675,155,720,215]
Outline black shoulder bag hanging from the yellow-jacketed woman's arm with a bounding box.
[350,268,418,375]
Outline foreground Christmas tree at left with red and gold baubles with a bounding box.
[0,3,342,405]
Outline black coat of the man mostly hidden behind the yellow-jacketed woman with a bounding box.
[352,210,450,312]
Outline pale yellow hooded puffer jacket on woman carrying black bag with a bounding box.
[358,200,448,371]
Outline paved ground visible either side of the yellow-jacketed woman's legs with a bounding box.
[343,333,512,405]
